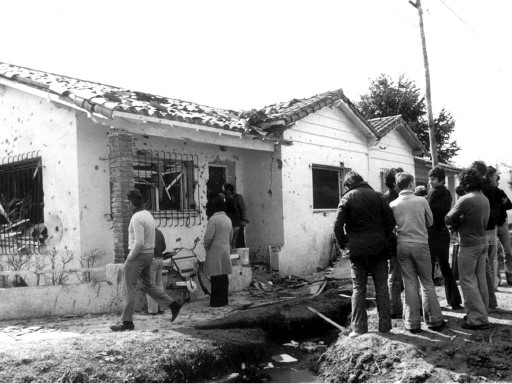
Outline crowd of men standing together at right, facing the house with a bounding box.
[334,161,512,337]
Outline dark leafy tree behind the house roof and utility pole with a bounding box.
[357,74,460,163]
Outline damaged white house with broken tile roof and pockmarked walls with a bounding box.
[0,63,424,275]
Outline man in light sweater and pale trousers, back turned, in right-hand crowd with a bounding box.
[390,172,445,333]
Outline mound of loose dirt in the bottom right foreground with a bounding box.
[318,325,512,383]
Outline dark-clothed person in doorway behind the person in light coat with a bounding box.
[222,183,249,252]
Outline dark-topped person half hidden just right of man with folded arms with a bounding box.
[471,161,501,309]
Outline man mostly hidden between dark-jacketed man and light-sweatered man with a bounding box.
[384,168,404,319]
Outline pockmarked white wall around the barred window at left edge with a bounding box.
[0,85,80,262]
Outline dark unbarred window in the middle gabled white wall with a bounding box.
[312,164,346,209]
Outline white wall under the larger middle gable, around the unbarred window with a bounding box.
[279,107,369,275]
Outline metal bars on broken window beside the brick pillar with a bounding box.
[133,150,202,227]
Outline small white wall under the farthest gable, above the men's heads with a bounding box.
[368,130,415,192]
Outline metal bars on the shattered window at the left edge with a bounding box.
[0,151,44,255]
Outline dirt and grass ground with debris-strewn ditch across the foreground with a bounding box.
[0,270,512,382]
